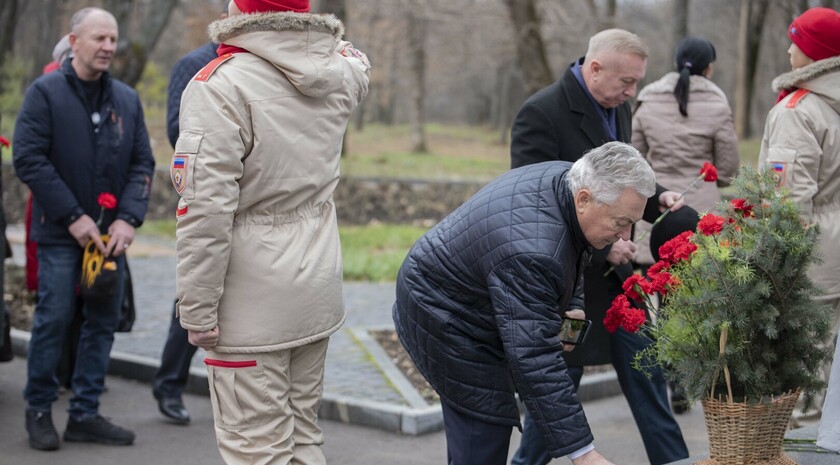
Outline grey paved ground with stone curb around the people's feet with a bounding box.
[0,227,838,465]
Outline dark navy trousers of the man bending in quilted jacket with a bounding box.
[440,400,513,465]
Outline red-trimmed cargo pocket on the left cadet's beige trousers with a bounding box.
[204,354,274,430]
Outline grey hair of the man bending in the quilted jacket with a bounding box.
[566,142,656,205]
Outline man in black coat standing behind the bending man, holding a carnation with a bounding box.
[510,29,688,465]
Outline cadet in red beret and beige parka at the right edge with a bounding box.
[758,8,840,431]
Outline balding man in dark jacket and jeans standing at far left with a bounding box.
[13,8,154,450]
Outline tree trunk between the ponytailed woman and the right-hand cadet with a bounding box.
[735,0,769,138]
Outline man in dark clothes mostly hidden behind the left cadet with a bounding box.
[152,38,221,425]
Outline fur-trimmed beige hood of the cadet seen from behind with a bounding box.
[208,12,344,97]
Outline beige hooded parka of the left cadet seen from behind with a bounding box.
[170,12,370,353]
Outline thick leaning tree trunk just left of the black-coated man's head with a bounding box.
[505,0,554,95]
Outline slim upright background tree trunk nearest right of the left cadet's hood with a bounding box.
[407,8,428,153]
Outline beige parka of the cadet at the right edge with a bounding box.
[758,57,840,298]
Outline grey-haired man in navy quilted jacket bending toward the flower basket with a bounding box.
[393,142,677,465]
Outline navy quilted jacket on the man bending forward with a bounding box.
[393,162,592,457]
